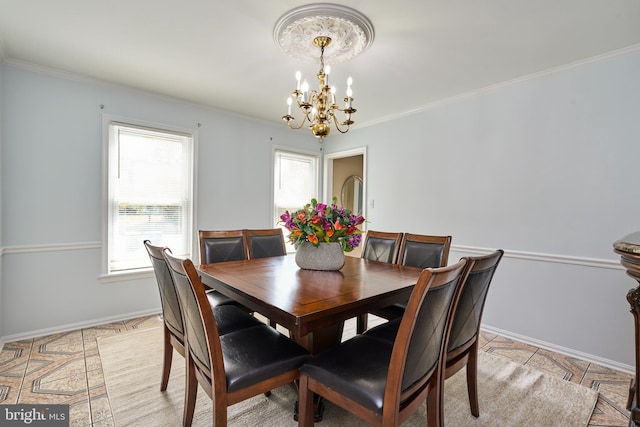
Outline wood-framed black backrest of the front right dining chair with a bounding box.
[383,258,470,414]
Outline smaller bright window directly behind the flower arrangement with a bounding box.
[273,150,318,251]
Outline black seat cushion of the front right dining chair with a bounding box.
[300,335,393,414]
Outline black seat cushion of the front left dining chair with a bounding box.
[220,323,310,392]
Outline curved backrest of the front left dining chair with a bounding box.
[163,250,226,380]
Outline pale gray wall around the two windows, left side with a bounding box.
[0,62,319,339]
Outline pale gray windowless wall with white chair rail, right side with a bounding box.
[326,49,640,366]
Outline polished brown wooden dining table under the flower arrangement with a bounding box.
[198,254,422,354]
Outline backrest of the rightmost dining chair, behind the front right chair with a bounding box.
[447,249,504,357]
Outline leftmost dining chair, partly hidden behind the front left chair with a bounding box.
[144,240,263,391]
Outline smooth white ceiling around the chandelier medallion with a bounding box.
[0,0,640,126]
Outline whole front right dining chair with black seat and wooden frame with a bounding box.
[298,259,468,427]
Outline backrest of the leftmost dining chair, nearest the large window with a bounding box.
[144,240,184,340]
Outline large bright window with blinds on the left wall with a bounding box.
[106,121,194,274]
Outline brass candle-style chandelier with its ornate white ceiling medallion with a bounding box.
[274,4,373,142]
